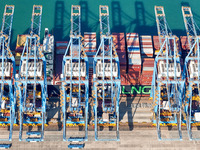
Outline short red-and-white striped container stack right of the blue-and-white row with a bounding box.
[140,35,153,58]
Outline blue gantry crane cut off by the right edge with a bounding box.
[182,6,200,140]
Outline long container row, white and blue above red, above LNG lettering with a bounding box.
[126,33,141,85]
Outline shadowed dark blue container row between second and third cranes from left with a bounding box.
[54,41,68,85]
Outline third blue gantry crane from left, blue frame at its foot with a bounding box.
[60,5,89,148]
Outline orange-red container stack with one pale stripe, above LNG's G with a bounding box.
[140,58,154,85]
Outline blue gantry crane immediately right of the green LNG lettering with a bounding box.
[150,6,184,140]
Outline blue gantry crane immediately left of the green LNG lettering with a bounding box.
[92,5,121,141]
